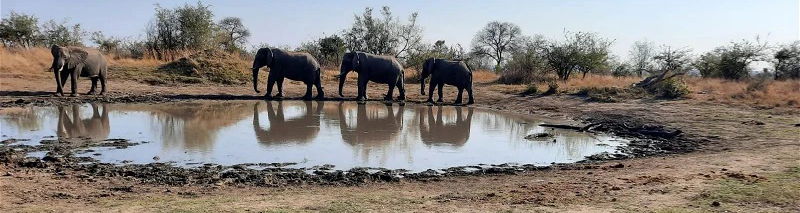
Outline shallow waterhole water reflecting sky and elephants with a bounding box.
[0,101,627,171]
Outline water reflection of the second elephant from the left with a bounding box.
[253,101,325,145]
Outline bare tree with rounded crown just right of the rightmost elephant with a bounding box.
[472,21,523,68]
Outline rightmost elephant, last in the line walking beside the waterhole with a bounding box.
[419,58,475,104]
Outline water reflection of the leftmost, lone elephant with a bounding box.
[56,104,111,140]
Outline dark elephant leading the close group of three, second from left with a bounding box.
[253,48,325,100]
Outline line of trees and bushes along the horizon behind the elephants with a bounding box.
[0,2,800,80]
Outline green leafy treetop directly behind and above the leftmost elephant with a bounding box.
[41,20,86,46]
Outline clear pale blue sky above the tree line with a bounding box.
[0,0,800,58]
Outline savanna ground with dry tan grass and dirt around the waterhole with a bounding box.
[0,47,800,212]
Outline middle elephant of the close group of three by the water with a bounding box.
[339,52,406,101]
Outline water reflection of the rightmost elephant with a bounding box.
[419,106,472,147]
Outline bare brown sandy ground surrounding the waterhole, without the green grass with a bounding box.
[0,76,800,212]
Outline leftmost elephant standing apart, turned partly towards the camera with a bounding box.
[50,45,108,97]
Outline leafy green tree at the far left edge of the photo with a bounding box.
[0,11,39,48]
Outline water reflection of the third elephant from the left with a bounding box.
[339,102,405,151]
